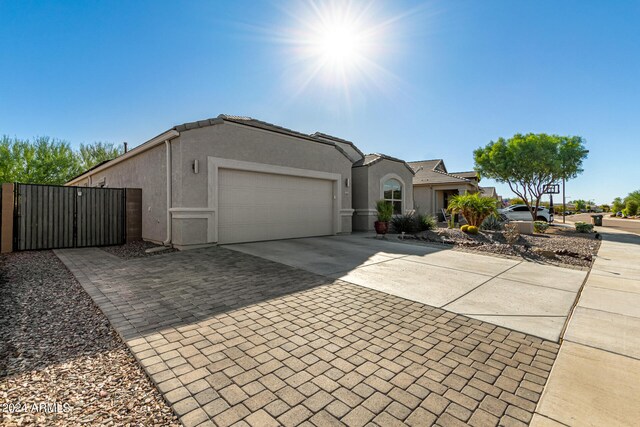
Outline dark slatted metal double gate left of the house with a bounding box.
[13,184,126,251]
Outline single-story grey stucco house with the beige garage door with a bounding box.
[67,115,413,249]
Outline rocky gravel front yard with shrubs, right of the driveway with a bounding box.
[405,226,600,268]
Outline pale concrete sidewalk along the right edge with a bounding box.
[531,228,640,426]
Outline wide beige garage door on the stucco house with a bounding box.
[218,169,334,243]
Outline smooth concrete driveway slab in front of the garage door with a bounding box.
[226,234,586,341]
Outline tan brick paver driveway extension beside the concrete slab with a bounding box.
[56,248,558,427]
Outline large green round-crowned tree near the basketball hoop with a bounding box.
[473,133,588,221]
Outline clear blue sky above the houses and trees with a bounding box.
[0,0,640,202]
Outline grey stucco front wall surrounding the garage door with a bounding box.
[173,123,353,245]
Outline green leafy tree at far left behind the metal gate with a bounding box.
[0,136,79,184]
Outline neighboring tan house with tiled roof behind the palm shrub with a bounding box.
[408,159,479,220]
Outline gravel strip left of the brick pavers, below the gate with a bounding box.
[0,251,179,426]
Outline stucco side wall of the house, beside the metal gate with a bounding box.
[75,145,169,242]
